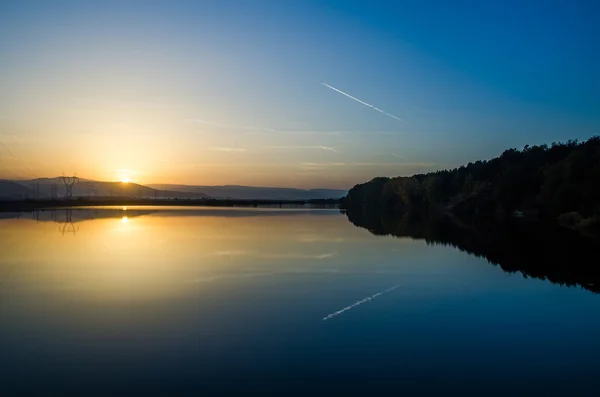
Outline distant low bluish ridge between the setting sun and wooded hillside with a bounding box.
[148,184,347,200]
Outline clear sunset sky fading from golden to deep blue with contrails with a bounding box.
[0,0,600,189]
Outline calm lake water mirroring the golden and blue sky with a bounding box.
[0,208,600,396]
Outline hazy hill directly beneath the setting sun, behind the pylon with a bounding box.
[12,177,207,199]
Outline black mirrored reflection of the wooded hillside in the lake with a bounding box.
[346,211,600,293]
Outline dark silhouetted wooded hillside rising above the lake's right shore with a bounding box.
[342,136,600,227]
